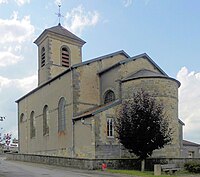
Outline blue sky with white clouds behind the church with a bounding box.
[0,0,200,143]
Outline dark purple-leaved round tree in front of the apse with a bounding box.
[115,90,172,171]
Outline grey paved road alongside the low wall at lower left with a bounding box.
[0,158,130,177]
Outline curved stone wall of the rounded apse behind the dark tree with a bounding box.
[122,77,182,158]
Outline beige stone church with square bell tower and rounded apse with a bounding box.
[16,24,183,159]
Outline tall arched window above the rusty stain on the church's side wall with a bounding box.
[58,97,66,132]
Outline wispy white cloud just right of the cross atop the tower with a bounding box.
[65,5,100,35]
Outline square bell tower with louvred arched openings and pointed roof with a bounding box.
[34,23,85,86]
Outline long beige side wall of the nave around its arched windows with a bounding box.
[18,73,73,157]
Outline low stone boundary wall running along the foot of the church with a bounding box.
[6,153,200,170]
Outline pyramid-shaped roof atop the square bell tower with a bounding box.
[34,23,86,45]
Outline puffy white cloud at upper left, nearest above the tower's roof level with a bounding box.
[0,12,34,43]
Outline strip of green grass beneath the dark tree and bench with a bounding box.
[106,169,200,177]
